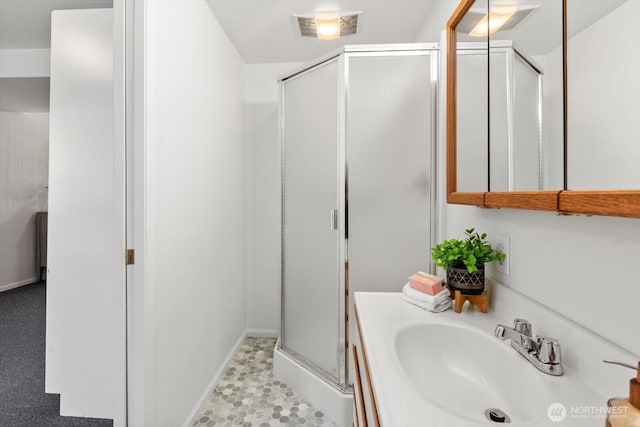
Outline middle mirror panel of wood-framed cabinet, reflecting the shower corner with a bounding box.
[488,0,564,192]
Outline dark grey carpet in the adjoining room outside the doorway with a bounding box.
[0,282,113,427]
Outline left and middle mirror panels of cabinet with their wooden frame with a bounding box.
[447,0,564,210]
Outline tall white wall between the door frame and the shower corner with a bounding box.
[145,0,245,427]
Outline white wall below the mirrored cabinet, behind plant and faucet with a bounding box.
[425,0,640,358]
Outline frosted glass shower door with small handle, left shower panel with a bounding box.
[281,60,341,383]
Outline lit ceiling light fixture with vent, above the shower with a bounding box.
[294,12,361,40]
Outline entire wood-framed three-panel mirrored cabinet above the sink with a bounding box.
[447,0,640,217]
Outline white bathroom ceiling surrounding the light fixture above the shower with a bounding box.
[206,0,442,64]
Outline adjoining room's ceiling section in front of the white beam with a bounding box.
[0,0,113,49]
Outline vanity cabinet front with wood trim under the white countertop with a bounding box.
[351,307,380,427]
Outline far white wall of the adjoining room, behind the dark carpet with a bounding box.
[0,111,49,291]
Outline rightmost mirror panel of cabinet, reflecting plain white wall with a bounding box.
[567,0,640,190]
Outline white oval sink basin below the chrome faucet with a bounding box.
[395,323,553,423]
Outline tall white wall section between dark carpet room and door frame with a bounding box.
[46,9,116,418]
